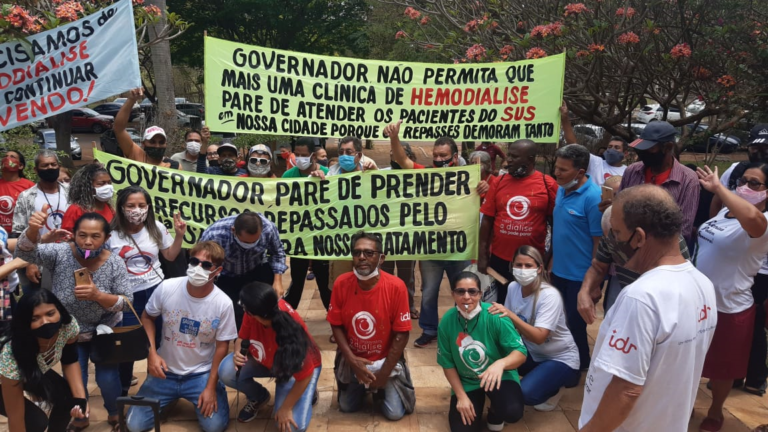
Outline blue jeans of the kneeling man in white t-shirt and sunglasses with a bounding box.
[126,372,229,432]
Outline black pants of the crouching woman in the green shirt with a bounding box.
[448,380,524,432]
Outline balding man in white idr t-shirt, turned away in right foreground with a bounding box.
[579,185,717,432]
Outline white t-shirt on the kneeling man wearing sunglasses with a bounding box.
[144,276,237,375]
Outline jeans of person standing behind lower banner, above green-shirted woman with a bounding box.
[419,260,469,336]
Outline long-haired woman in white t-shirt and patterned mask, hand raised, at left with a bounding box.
[110,186,187,394]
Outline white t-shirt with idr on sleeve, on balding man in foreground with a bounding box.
[579,262,717,432]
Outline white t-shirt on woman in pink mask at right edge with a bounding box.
[694,208,768,314]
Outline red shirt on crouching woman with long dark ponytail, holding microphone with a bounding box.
[238,299,323,381]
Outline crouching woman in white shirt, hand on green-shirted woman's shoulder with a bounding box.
[488,245,580,411]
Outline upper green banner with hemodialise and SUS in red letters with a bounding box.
[205,37,565,142]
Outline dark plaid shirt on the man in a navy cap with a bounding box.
[619,160,700,240]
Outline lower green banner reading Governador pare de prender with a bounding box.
[94,150,480,260]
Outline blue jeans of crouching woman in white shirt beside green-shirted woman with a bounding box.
[517,355,581,405]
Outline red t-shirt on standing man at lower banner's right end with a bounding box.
[480,171,558,261]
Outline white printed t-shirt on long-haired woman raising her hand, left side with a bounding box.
[110,221,173,292]
